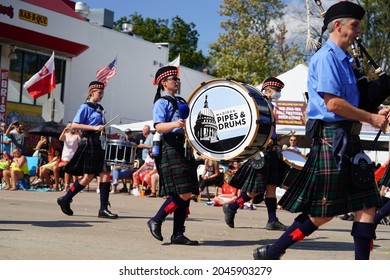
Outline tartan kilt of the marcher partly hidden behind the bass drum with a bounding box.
[229,151,282,194]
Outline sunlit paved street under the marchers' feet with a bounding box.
[0,187,390,260]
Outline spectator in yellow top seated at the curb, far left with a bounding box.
[3,148,30,191]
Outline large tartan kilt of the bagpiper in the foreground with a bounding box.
[279,128,381,217]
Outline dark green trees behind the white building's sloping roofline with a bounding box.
[114,13,208,70]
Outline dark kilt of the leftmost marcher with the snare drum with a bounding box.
[65,137,105,176]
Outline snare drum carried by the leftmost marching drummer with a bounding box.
[104,140,137,165]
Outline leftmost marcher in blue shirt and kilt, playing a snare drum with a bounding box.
[57,81,118,219]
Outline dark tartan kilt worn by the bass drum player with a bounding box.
[157,138,199,196]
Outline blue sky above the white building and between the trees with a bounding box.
[84,0,338,55]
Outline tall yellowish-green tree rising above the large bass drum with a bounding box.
[209,0,303,84]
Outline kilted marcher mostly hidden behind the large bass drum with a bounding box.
[222,77,287,230]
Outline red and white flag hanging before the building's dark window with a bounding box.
[24,52,56,99]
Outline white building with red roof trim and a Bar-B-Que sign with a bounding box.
[0,0,212,152]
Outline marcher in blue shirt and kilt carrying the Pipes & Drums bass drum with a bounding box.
[147,66,198,245]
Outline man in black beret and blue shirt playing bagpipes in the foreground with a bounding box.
[253,2,389,260]
